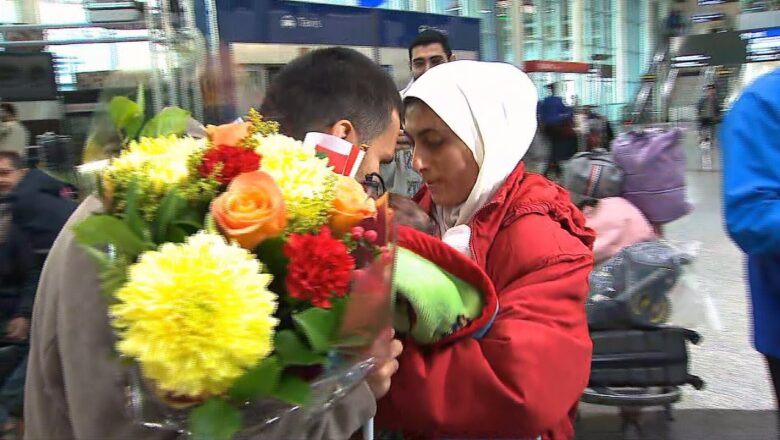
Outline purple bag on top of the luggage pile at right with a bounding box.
[612,128,691,224]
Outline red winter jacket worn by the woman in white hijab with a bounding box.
[376,164,594,440]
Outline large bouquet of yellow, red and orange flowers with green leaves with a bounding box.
[74,97,394,438]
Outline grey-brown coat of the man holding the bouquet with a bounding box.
[25,198,376,440]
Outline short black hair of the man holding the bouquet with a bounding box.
[260,47,401,142]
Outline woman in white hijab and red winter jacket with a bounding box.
[377,61,593,440]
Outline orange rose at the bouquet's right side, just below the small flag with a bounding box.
[330,175,376,236]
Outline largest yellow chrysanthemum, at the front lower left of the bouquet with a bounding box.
[110,232,278,397]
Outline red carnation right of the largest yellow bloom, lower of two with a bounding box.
[284,227,355,309]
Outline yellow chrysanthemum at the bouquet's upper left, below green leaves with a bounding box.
[108,135,206,189]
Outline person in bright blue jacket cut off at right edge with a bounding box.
[720,69,780,418]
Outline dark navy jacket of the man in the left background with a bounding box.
[10,168,77,254]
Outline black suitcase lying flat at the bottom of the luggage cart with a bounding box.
[589,327,703,389]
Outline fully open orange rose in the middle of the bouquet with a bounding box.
[211,171,287,251]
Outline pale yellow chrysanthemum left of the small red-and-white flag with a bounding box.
[256,134,336,232]
